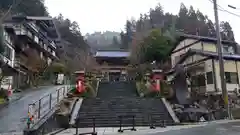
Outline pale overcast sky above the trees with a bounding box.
[45,0,240,43]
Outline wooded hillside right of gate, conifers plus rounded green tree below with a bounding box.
[124,3,235,65]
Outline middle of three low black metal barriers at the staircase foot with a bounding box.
[118,115,137,133]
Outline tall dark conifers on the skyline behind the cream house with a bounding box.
[122,3,235,48]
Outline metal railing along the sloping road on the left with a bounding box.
[27,86,71,128]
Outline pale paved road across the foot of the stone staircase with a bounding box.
[48,120,240,135]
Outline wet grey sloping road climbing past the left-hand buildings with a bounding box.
[0,86,66,134]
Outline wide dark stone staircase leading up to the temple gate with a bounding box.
[78,82,174,127]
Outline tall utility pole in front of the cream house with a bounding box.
[213,0,231,118]
